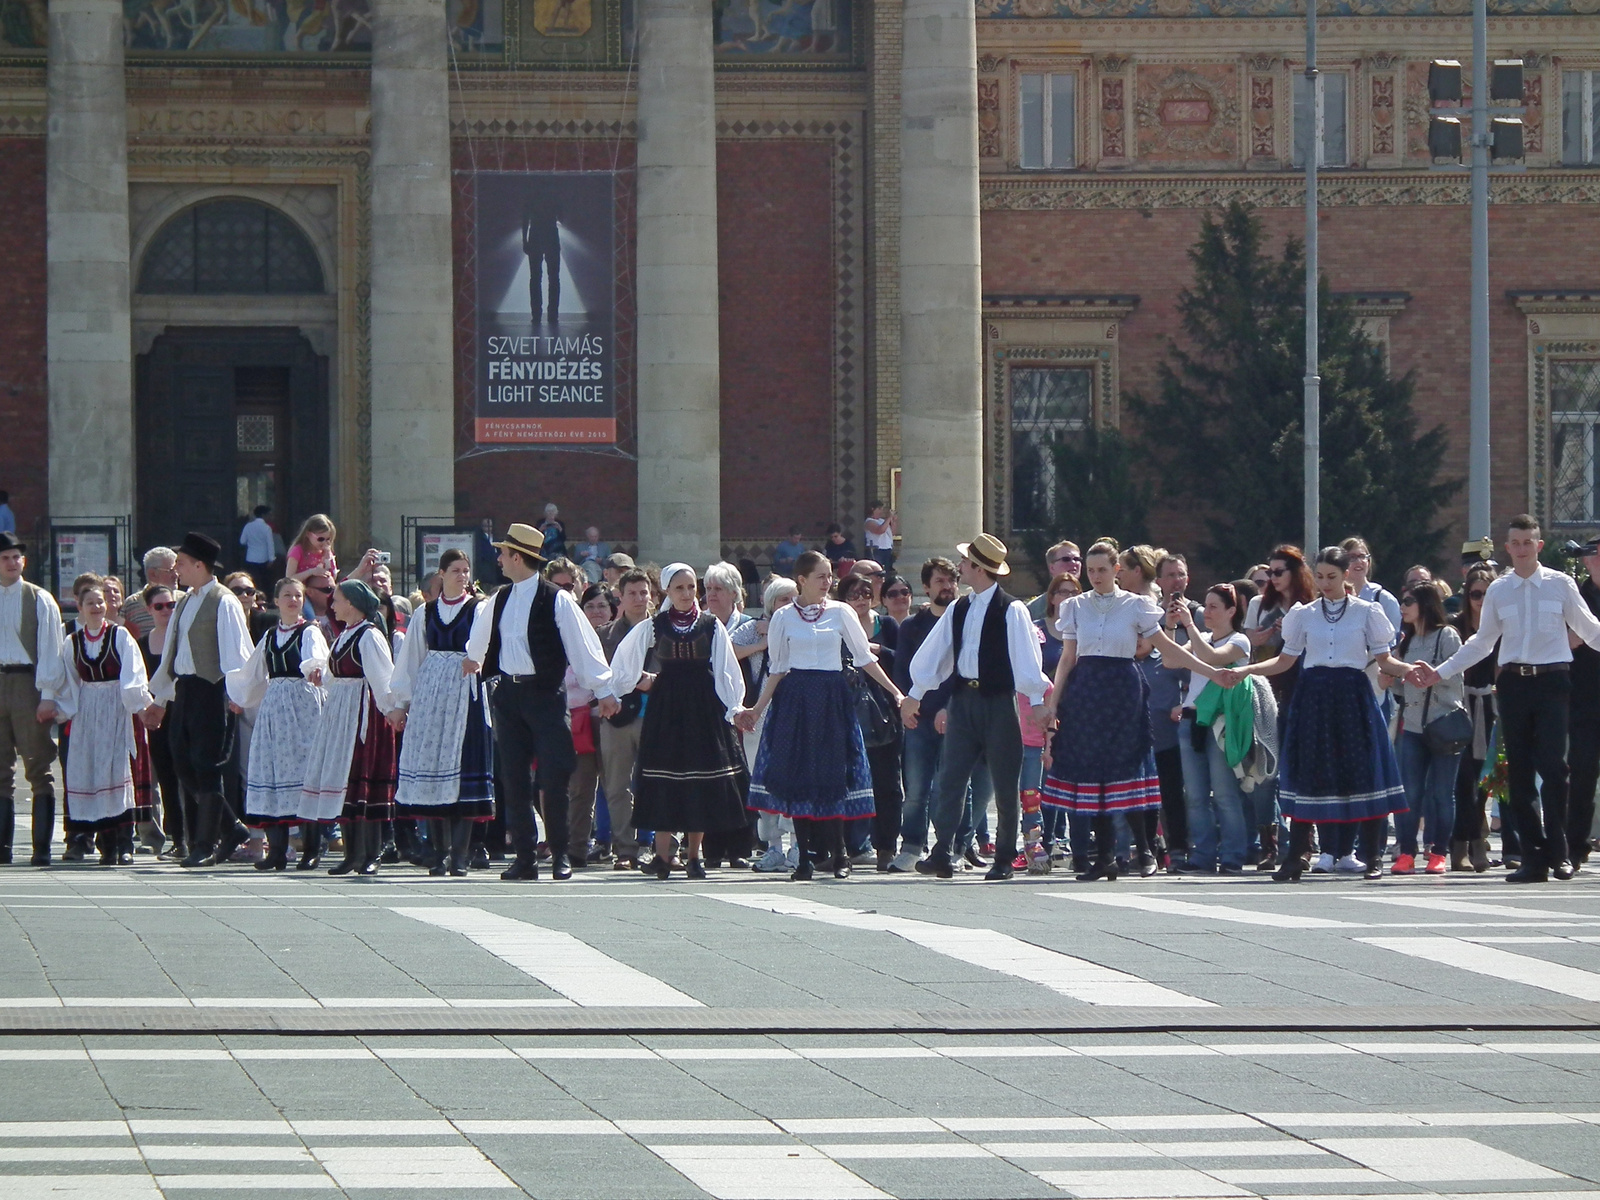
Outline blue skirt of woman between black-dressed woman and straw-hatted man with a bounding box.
[750,670,874,821]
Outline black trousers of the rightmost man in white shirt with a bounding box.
[1496,670,1573,867]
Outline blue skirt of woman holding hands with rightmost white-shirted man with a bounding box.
[1278,667,1406,822]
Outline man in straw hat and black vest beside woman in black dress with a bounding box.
[462,525,619,880]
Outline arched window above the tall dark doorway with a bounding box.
[139,200,323,296]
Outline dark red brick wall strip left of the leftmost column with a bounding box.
[0,138,50,539]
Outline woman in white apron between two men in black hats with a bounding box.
[58,581,154,867]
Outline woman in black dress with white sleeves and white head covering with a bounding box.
[611,563,749,878]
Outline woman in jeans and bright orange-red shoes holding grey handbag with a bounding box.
[1390,582,1466,875]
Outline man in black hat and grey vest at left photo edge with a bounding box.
[0,533,66,867]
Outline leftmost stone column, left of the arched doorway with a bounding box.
[45,0,134,517]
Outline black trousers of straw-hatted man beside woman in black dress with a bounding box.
[490,678,578,862]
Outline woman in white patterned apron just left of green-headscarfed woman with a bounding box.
[227,576,328,870]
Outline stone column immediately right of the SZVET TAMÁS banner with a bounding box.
[634,0,722,570]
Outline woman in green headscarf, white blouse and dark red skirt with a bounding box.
[299,579,398,875]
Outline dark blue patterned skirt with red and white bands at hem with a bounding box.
[1043,654,1162,816]
